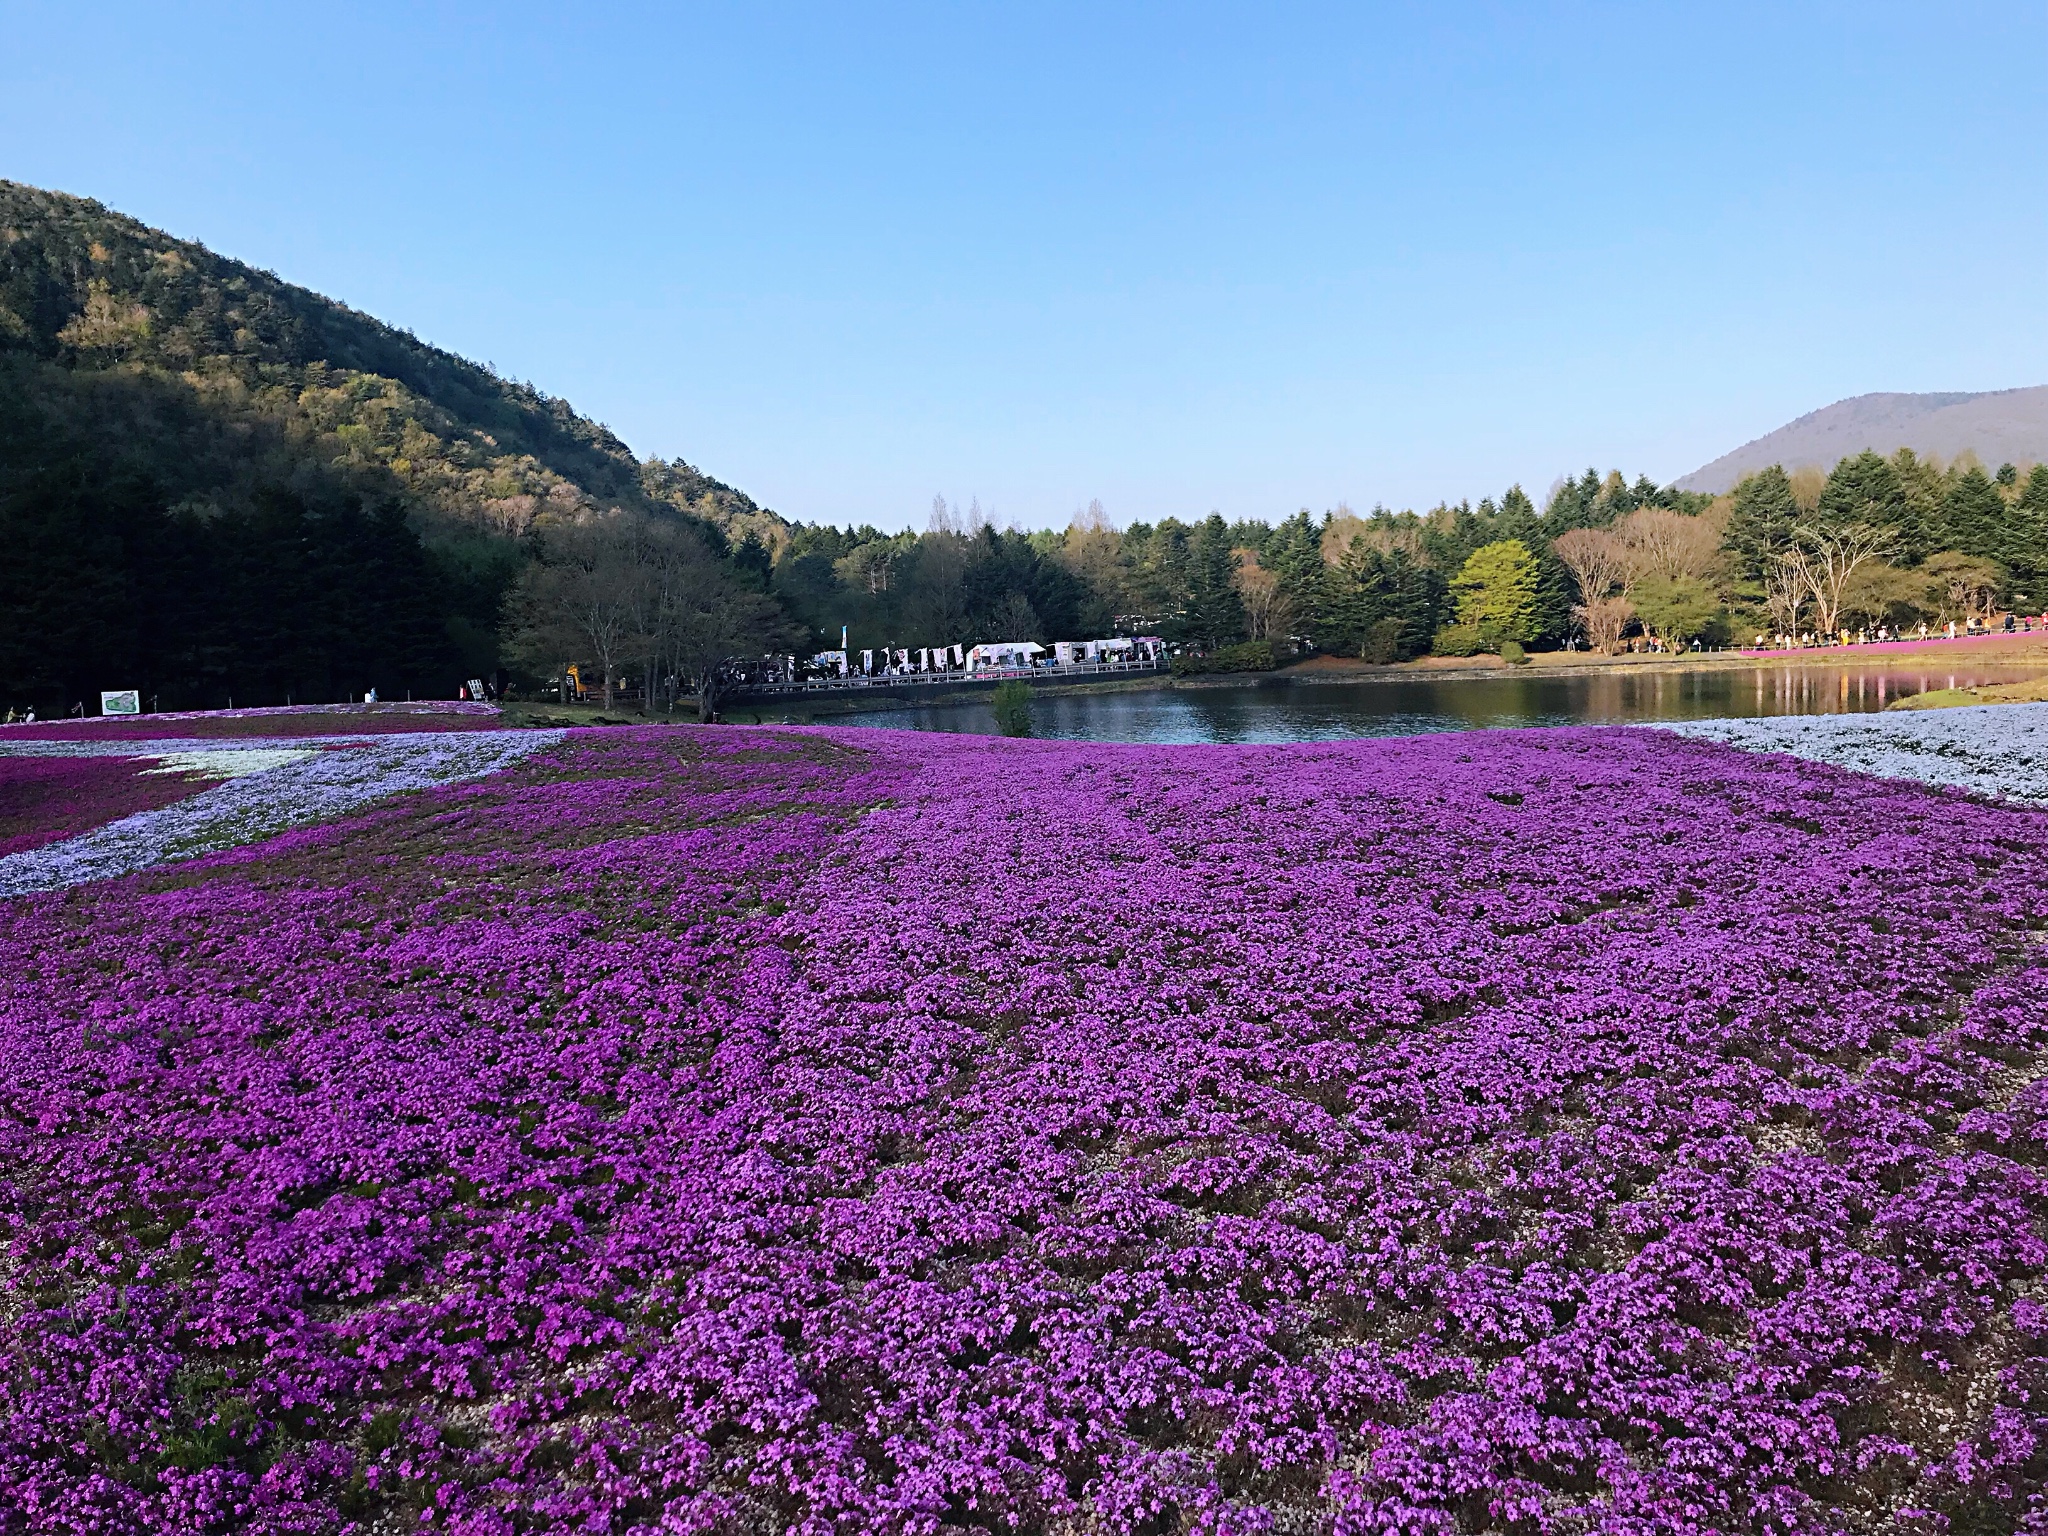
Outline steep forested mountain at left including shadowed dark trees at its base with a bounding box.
[0,182,784,709]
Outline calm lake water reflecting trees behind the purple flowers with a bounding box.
[834,664,2040,743]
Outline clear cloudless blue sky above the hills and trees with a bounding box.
[0,0,2048,526]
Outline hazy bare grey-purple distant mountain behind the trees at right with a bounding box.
[1677,385,2048,494]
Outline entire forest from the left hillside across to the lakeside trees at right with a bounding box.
[0,182,2048,713]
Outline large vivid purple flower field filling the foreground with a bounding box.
[0,729,2048,1536]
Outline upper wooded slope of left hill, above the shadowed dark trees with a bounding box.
[0,180,782,543]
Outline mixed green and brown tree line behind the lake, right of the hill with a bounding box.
[712,449,2048,679]
